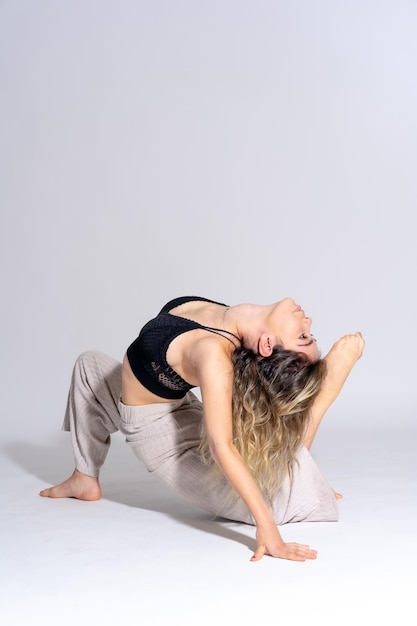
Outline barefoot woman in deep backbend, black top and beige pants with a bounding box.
[41,296,364,561]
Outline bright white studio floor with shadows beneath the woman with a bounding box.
[0,420,417,626]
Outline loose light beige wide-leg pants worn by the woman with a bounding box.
[63,352,338,524]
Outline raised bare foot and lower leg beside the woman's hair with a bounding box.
[303,333,365,449]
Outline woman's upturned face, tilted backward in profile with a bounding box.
[269,298,320,361]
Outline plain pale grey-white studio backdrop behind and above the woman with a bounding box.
[0,0,417,441]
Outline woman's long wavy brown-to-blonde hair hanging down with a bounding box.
[200,347,326,500]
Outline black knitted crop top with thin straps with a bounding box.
[126,296,240,400]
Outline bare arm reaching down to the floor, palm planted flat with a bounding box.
[195,341,317,561]
